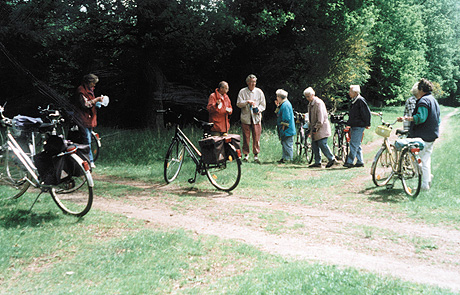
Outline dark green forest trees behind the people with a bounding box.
[0,0,460,128]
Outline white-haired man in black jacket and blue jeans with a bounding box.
[343,85,371,168]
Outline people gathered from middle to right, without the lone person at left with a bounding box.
[207,74,440,190]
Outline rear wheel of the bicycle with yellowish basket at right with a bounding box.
[399,148,422,199]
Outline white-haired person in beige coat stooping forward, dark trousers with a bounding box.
[303,87,336,168]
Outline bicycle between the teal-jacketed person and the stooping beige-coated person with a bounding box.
[294,111,313,164]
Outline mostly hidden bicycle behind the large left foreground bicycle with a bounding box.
[38,104,102,162]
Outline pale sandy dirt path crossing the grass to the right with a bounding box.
[94,109,460,291]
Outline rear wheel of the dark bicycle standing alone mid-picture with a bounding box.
[204,148,241,192]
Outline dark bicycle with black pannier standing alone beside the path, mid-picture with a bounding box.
[157,109,241,192]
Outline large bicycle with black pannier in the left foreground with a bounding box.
[0,107,94,217]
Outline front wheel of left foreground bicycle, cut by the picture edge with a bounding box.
[0,146,30,200]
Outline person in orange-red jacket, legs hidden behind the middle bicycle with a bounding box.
[206,81,233,136]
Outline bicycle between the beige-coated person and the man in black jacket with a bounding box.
[330,114,350,163]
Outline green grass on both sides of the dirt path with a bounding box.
[0,108,460,294]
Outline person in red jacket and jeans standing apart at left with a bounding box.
[77,74,103,168]
